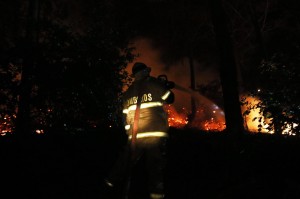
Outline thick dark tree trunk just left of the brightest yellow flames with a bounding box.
[210,0,244,135]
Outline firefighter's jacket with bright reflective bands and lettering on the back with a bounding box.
[123,76,174,138]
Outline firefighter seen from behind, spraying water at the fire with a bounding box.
[105,62,174,199]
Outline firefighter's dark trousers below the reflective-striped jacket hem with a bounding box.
[107,137,167,194]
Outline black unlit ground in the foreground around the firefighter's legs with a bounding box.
[0,126,300,199]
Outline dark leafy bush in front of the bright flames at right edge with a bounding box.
[243,51,300,135]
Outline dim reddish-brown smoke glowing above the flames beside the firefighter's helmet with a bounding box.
[127,37,218,112]
